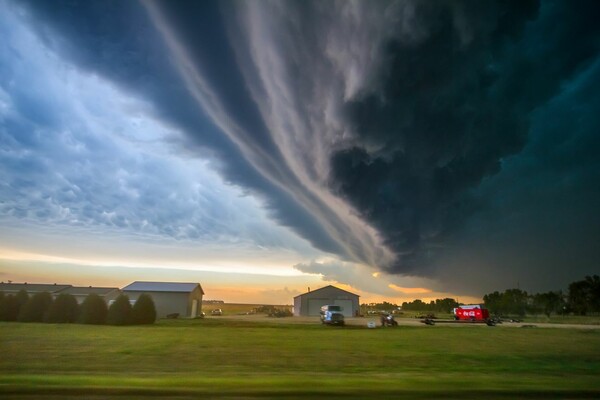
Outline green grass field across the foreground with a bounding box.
[0,314,600,399]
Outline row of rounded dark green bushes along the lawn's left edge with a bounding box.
[0,290,156,325]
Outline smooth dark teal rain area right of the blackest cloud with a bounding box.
[440,54,600,291]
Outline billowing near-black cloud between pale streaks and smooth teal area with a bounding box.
[331,2,600,282]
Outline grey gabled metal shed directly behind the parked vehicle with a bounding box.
[294,285,360,317]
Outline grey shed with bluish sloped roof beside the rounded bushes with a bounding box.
[123,282,204,318]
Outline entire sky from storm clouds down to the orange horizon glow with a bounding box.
[0,0,600,304]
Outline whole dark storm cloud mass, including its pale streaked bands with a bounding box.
[0,0,600,295]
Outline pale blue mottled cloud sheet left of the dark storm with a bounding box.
[0,5,324,278]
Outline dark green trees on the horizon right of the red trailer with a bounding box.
[483,275,600,317]
